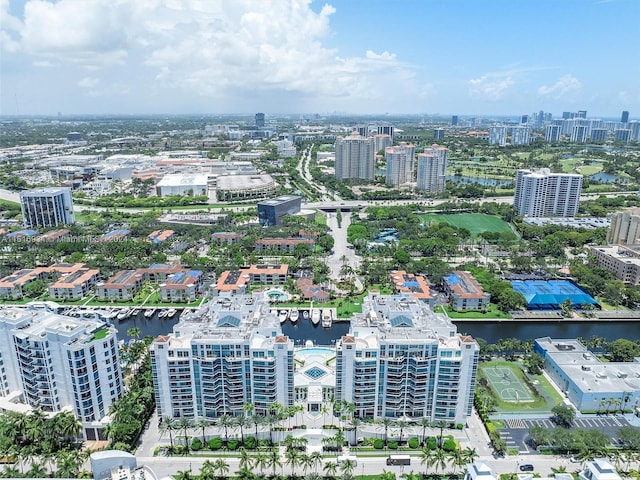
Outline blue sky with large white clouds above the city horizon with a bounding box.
[0,0,640,118]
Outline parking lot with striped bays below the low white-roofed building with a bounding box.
[500,416,629,453]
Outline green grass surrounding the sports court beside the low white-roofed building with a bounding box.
[478,359,562,413]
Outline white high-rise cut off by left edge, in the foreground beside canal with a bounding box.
[0,307,124,440]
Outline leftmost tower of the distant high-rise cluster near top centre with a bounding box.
[335,135,376,180]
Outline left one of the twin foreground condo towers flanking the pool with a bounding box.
[151,293,294,418]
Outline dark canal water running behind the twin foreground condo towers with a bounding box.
[113,314,640,346]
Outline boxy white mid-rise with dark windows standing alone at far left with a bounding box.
[20,187,75,228]
